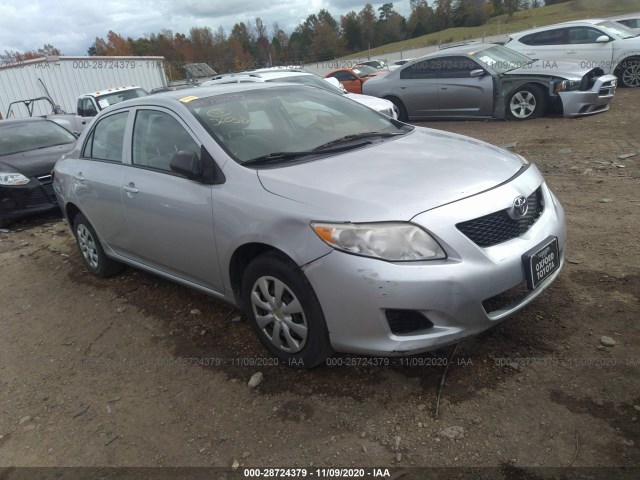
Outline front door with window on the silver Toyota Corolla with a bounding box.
[121,108,223,292]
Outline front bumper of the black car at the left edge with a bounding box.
[0,174,58,220]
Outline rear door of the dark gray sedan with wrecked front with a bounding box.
[394,59,439,118]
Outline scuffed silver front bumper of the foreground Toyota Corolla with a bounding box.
[305,166,566,355]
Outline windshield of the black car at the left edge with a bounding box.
[0,120,76,157]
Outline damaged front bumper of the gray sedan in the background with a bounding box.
[558,75,617,118]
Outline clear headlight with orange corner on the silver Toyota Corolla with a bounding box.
[311,222,447,262]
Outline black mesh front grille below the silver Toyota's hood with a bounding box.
[456,187,544,247]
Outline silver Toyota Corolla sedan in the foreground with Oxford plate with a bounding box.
[54,83,566,368]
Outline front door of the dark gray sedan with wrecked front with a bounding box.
[438,56,493,117]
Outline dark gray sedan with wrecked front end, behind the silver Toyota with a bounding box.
[363,43,617,121]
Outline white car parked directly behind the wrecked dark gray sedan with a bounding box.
[505,19,640,88]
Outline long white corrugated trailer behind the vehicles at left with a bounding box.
[0,56,167,117]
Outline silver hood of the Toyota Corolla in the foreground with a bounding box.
[258,127,522,222]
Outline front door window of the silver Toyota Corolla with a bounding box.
[131,110,200,172]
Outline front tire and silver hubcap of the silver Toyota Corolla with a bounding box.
[242,253,332,370]
